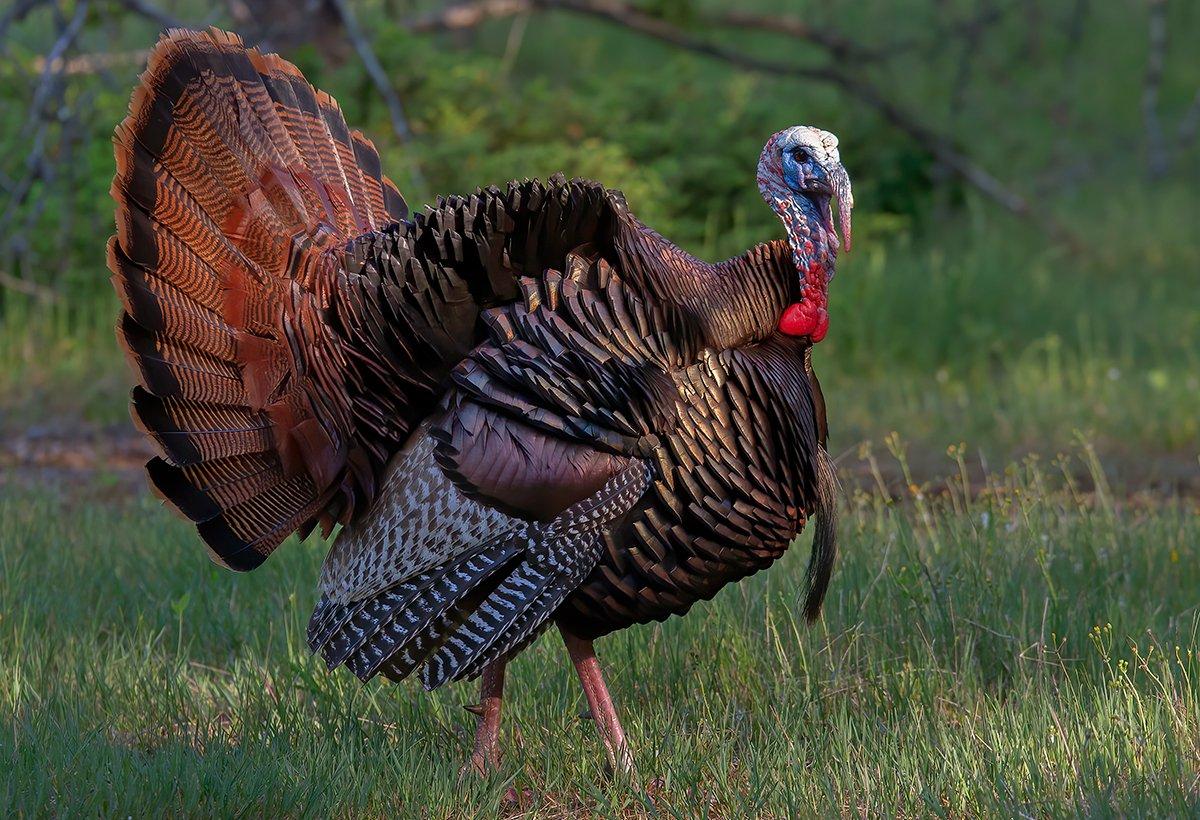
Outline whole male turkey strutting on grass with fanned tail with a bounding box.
[108,30,852,768]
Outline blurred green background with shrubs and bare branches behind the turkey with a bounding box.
[0,0,1200,496]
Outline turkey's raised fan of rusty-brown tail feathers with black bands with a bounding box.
[108,30,407,569]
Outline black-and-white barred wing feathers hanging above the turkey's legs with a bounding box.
[308,461,652,689]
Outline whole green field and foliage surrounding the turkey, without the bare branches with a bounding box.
[0,0,1200,819]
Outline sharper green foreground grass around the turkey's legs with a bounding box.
[0,450,1200,818]
